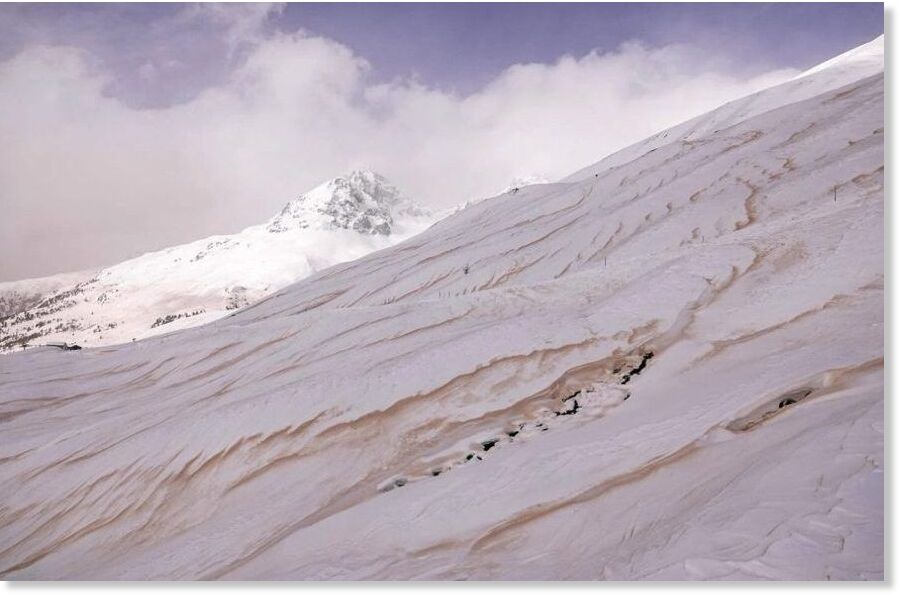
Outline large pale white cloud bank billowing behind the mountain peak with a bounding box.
[0,8,796,280]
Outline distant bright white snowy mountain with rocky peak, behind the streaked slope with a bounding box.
[0,171,434,351]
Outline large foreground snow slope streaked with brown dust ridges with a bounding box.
[0,36,884,579]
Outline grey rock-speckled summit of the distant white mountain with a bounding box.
[267,170,409,235]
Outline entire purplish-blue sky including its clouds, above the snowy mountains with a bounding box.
[0,3,883,281]
